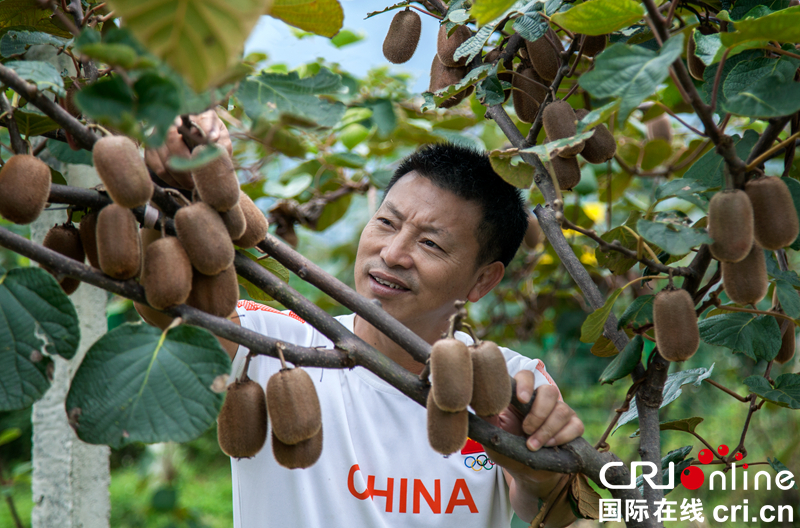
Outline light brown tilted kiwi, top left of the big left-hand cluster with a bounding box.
[92,136,153,209]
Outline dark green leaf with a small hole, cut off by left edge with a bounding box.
[0,268,80,411]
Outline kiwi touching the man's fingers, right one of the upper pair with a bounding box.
[469,341,511,416]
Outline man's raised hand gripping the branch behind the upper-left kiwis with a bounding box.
[144,109,233,190]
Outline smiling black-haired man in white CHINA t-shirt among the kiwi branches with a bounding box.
[150,130,583,528]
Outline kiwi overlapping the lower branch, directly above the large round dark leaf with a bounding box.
[141,237,192,310]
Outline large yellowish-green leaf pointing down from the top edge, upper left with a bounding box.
[109,0,269,91]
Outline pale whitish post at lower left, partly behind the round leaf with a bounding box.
[31,165,111,528]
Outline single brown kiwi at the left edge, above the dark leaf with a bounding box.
[0,154,50,224]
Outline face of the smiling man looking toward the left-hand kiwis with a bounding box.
[355,172,483,333]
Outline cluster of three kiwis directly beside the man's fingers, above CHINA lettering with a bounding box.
[426,337,511,455]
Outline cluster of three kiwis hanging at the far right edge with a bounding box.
[708,177,800,304]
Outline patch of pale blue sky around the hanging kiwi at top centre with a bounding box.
[245,0,439,93]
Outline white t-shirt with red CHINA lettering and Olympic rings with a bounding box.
[231,301,555,528]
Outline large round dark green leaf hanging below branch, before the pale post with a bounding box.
[66,323,230,448]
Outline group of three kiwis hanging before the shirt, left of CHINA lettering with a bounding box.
[217,366,322,469]
